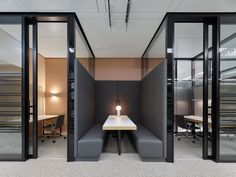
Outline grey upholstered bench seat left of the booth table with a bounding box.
[77,123,105,161]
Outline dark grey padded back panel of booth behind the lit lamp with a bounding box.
[95,81,141,123]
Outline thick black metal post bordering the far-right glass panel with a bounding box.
[212,17,220,162]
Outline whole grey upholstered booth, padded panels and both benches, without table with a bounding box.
[75,61,167,161]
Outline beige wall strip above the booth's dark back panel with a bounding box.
[95,58,141,80]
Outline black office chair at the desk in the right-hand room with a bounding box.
[175,115,200,143]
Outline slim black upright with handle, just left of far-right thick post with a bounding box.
[202,20,208,159]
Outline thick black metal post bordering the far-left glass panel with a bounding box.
[22,16,29,160]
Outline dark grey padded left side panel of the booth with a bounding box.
[74,60,95,157]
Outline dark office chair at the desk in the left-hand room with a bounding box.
[41,115,65,143]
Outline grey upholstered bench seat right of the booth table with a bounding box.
[131,124,163,161]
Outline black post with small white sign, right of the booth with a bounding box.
[165,15,175,162]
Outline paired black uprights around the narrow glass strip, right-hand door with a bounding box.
[202,17,219,161]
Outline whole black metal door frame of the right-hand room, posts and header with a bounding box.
[166,13,219,162]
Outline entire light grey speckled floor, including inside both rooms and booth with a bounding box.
[0,133,236,177]
